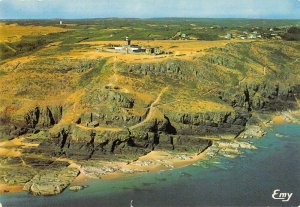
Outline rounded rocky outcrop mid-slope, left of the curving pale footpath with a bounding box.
[76,85,143,127]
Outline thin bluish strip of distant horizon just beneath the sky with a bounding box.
[0,17,300,21]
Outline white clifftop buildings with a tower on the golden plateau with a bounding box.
[103,37,166,55]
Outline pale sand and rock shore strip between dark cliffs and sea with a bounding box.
[69,110,300,187]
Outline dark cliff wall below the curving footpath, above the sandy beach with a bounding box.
[32,111,211,160]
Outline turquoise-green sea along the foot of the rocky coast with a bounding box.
[0,123,300,207]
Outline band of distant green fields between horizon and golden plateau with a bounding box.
[0,18,300,59]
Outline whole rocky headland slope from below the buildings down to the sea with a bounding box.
[0,41,300,195]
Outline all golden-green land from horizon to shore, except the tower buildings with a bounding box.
[0,19,300,195]
